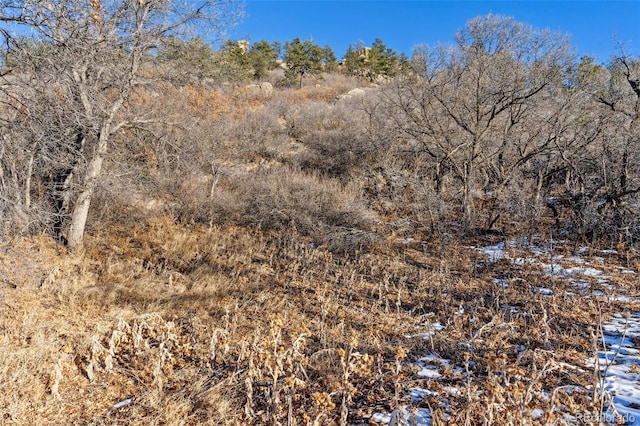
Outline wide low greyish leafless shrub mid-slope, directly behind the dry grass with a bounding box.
[184,168,376,251]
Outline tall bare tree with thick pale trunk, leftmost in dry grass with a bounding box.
[0,0,238,249]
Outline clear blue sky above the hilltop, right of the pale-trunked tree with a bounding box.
[229,0,640,62]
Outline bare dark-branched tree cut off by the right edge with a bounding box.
[574,48,640,241]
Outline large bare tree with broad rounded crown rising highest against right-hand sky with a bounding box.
[388,15,572,227]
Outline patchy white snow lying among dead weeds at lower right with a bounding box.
[370,239,640,426]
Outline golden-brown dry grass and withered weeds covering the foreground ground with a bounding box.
[0,218,635,425]
